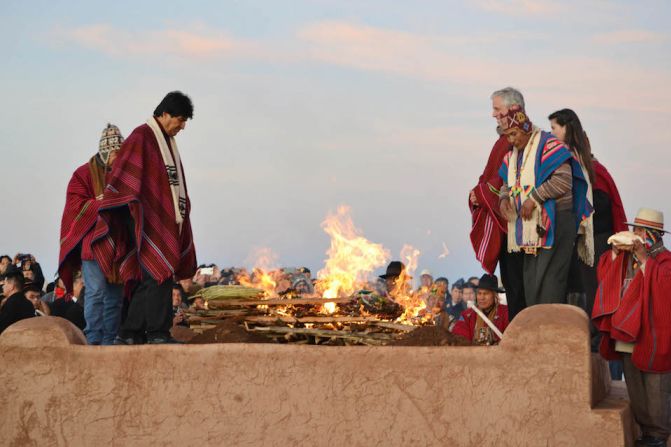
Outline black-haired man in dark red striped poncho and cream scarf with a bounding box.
[92,92,196,344]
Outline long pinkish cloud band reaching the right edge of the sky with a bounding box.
[298,21,671,113]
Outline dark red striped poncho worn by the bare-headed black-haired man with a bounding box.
[92,124,196,283]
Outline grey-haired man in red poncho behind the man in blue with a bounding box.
[469,87,526,320]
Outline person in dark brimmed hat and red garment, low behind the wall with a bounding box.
[452,274,508,345]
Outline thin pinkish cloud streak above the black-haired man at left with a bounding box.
[51,24,246,57]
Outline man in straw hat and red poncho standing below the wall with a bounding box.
[592,208,671,446]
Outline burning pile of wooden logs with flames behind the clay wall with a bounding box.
[181,207,448,345]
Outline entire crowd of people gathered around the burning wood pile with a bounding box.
[0,87,671,445]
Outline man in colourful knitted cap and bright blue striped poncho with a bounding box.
[499,108,592,306]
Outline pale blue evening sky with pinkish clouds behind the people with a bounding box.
[0,0,671,281]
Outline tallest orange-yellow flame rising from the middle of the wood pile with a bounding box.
[317,205,389,313]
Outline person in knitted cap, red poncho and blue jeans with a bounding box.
[58,124,123,345]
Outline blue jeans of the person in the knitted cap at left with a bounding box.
[82,261,122,345]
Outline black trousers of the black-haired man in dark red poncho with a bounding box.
[119,271,172,340]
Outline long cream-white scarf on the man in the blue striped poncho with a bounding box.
[508,126,542,253]
